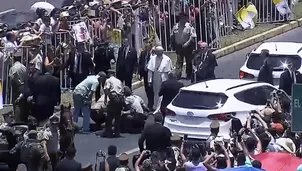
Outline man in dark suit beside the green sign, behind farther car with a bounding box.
[279,64,300,96]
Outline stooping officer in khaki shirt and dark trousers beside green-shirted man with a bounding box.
[102,76,125,138]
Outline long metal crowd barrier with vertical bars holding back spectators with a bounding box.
[0,0,295,103]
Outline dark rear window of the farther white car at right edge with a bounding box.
[246,53,301,71]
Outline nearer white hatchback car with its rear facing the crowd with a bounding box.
[164,79,276,140]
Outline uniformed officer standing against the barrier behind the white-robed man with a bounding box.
[171,14,197,79]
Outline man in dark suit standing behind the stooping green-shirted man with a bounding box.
[62,43,94,88]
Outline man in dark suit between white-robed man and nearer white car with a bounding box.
[159,72,184,117]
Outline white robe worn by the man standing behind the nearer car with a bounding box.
[147,54,173,107]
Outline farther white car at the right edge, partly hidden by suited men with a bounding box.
[239,42,302,85]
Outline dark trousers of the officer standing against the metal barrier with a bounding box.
[176,46,193,78]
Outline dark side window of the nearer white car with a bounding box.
[234,87,267,105]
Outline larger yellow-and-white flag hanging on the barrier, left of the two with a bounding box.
[236,3,258,29]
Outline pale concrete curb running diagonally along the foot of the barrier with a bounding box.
[132,18,302,90]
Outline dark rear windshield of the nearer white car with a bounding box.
[172,90,228,109]
